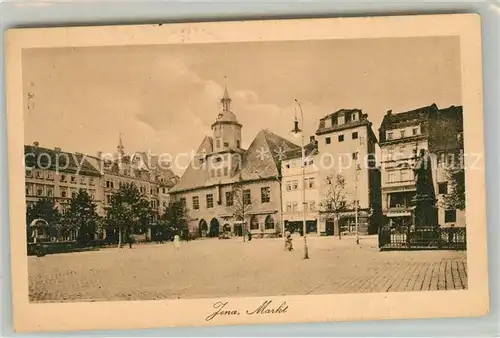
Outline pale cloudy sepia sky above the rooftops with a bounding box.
[23,37,461,174]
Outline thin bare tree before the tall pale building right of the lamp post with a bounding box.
[320,174,348,239]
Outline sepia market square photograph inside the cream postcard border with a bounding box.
[5,14,487,332]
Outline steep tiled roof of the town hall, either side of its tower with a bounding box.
[171,129,298,192]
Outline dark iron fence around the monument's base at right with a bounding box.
[378,226,467,250]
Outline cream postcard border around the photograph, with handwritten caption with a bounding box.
[5,14,489,332]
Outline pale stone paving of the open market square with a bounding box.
[28,236,467,301]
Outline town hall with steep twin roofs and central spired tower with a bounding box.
[171,88,298,237]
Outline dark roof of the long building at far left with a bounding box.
[24,145,101,176]
